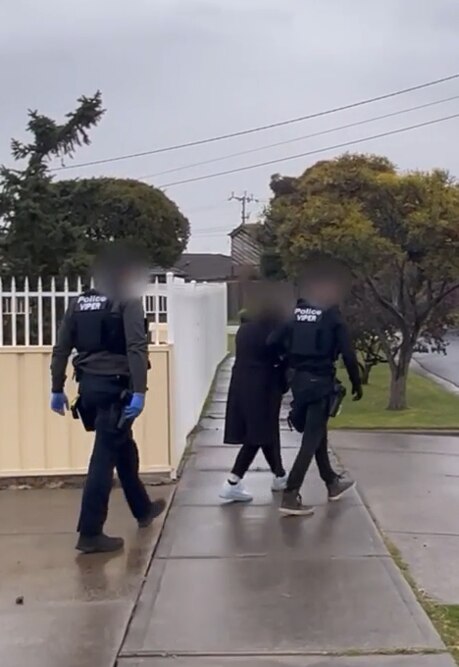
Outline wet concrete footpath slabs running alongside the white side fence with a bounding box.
[118,363,454,667]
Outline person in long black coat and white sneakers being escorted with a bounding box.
[220,308,287,502]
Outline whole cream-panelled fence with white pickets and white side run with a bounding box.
[0,275,227,477]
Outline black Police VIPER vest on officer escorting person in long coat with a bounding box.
[290,302,336,360]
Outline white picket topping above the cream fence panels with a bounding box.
[0,274,172,347]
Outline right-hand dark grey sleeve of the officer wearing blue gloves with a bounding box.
[123,299,148,394]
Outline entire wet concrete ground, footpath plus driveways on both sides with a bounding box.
[7,366,459,667]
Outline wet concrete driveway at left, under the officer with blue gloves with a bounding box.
[0,486,173,667]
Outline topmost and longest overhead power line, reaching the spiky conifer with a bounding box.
[52,73,459,171]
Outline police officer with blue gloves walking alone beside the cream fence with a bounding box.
[51,248,165,553]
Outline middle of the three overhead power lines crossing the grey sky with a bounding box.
[138,95,459,180]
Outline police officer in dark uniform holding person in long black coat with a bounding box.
[268,274,362,516]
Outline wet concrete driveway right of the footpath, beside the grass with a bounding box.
[331,432,459,604]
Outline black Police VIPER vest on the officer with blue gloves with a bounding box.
[72,290,127,354]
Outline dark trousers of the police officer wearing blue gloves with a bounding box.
[78,374,151,537]
